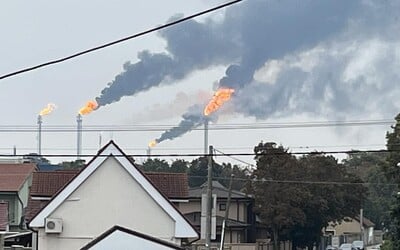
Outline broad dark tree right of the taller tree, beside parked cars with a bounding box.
[291,153,366,249]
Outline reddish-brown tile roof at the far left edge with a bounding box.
[0,163,36,192]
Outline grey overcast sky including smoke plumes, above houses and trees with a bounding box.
[0,0,400,167]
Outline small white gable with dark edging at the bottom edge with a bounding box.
[80,225,183,250]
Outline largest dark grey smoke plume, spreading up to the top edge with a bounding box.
[96,0,360,106]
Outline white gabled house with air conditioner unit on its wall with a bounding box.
[29,141,199,250]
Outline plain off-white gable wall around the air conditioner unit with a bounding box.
[39,158,178,250]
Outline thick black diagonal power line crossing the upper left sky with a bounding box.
[0,0,243,80]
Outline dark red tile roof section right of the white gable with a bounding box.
[144,172,189,198]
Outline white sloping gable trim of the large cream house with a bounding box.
[29,141,199,238]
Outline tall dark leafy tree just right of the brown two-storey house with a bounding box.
[251,142,310,249]
